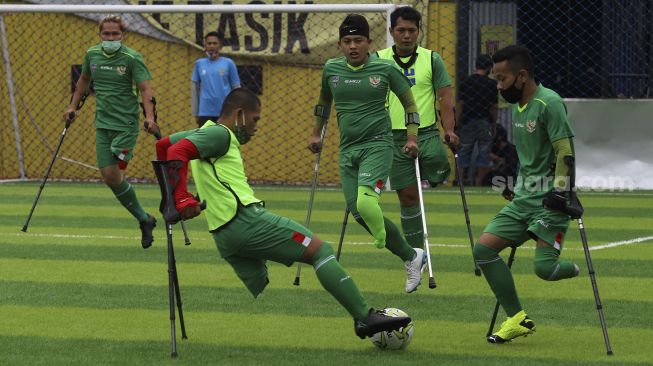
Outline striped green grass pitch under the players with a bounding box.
[0,183,653,366]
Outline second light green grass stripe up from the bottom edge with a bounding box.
[0,259,653,302]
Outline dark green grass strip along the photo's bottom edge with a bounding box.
[0,333,641,366]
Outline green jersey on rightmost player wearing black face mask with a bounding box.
[512,85,574,207]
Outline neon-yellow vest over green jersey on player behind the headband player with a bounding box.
[376,46,451,132]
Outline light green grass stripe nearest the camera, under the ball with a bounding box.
[0,306,653,363]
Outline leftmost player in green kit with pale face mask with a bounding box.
[64,16,159,248]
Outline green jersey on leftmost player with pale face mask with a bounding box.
[82,44,152,131]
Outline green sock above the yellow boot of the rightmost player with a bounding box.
[474,243,522,317]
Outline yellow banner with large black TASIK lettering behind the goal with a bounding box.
[129,0,428,64]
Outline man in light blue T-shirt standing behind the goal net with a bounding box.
[191,32,240,127]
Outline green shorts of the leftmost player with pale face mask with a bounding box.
[95,128,138,169]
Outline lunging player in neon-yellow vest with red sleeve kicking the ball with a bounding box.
[157,88,411,338]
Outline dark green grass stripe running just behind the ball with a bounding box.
[0,281,640,329]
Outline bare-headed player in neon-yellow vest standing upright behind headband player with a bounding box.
[376,6,458,248]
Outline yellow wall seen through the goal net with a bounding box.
[0,3,455,184]
